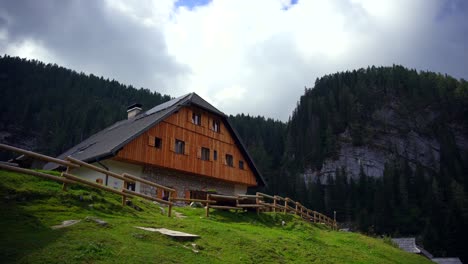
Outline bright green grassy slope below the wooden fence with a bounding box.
[0,171,431,263]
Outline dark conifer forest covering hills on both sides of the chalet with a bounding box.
[0,56,468,261]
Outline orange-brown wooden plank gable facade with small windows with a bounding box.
[114,107,257,186]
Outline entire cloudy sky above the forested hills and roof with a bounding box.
[0,0,468,120]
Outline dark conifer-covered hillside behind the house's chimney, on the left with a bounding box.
[0,55,171,158]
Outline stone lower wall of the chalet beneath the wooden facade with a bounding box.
[140,167,247,197]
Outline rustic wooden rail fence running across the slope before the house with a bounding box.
[0,144,338,229]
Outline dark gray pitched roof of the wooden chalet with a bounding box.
[44,93,266,185]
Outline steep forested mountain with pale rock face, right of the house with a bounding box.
[283,66,468,260]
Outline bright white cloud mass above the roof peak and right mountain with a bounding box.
[160,0,464,120]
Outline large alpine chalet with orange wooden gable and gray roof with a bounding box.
[44,93,265,198]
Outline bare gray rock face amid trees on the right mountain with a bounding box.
[303,103,468,183]
